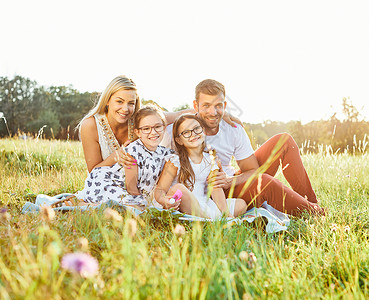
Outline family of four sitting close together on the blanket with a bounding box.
[48,76,324,219]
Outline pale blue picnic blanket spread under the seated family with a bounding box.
[22,193,290,233]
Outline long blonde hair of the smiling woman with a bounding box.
[77,75,140,131]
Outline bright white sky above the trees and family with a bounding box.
[0,0,369,123]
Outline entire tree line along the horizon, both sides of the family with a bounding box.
[0,76,369,152]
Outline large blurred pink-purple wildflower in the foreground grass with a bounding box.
[61,253,99,278]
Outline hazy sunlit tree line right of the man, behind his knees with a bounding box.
[245,98,369,153]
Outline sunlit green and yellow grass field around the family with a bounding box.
[0,139,369,299]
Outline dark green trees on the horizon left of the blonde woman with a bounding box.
[0,76,97,139]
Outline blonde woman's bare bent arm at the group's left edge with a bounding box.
[81,117,121,172]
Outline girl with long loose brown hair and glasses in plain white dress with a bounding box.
[173,114,247,219]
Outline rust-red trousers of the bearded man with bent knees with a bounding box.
[226,133,324,215]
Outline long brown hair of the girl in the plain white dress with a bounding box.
[173,114,205,191]
